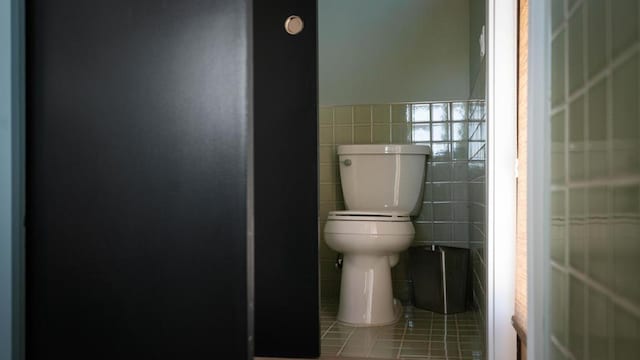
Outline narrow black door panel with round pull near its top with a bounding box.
[253,0,320,357]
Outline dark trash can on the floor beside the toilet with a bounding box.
[409,246,471,314]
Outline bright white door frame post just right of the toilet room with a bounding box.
[486,0,518,360]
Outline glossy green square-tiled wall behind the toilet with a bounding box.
[319,101,484,302]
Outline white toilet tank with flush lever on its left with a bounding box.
[338,144,431,215]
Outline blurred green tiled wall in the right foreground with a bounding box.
[548,0,640,359]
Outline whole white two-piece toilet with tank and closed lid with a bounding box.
[324,145,431,326]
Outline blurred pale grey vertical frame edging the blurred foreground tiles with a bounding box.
[527,0,551,359]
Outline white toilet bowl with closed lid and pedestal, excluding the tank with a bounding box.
[324,211,415,326]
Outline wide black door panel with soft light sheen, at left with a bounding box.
[26,0,252,360]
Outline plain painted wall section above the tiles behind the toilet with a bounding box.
[318,0,469,105]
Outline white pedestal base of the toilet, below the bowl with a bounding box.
[337,254,402,326]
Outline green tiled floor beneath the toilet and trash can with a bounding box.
[320,303,483,360]
